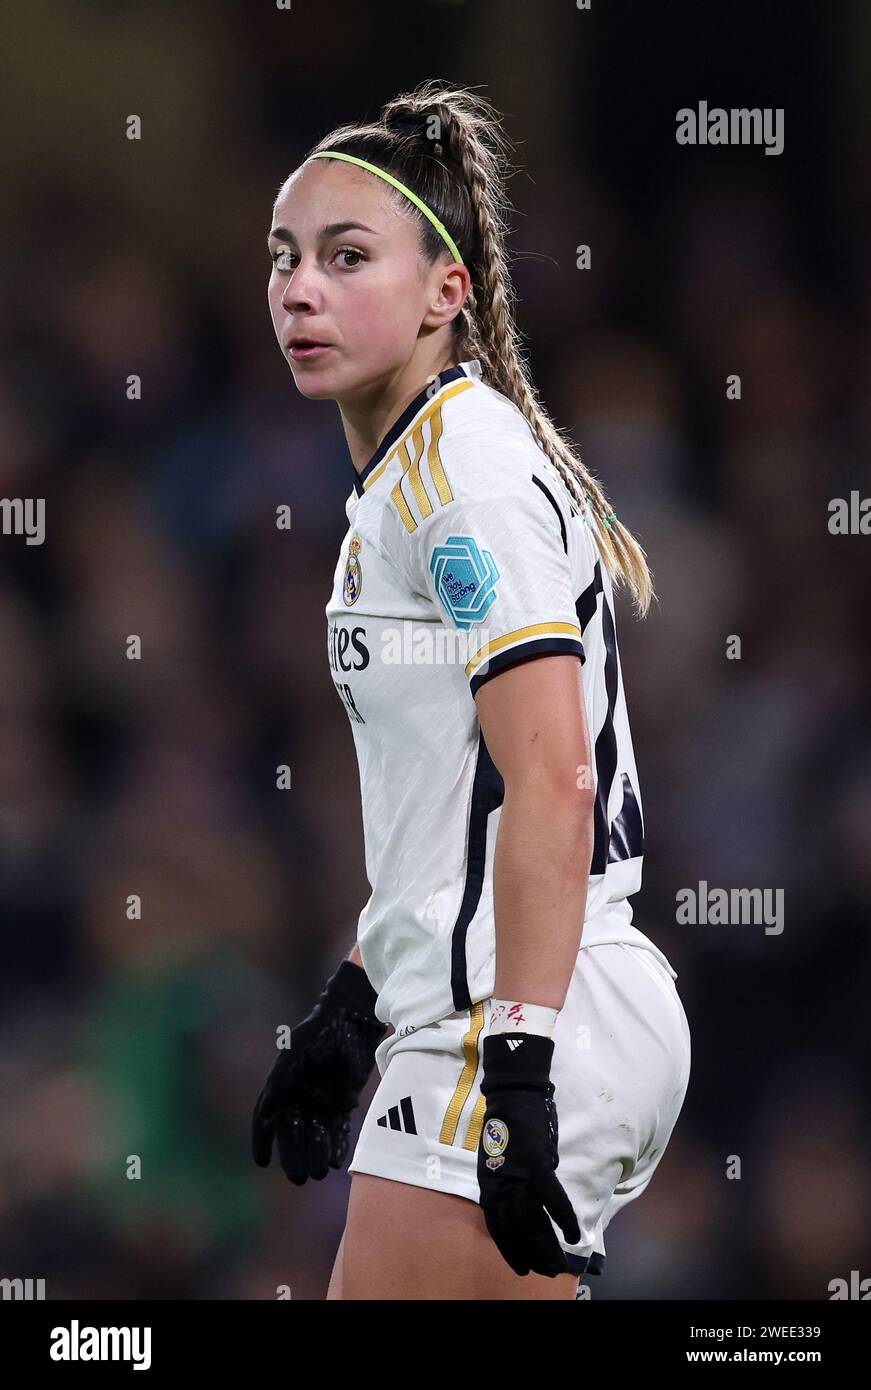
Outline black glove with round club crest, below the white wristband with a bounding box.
[478,1033,581,1277]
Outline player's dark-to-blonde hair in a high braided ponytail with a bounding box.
[310,78,653,616]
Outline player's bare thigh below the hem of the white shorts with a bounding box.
[336,1173,578,1300]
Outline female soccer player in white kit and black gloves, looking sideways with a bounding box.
[253,81,690,1300]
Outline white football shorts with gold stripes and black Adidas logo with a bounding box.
[349,941,690,1275]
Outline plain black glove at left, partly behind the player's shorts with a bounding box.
[251,960,388,1187]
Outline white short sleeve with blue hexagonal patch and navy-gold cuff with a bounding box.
[404,470,585,695]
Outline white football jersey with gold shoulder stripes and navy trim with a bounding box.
[326,360,675,1031]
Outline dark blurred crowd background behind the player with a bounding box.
[0,0,871,1300]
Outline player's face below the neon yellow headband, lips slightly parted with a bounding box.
[269,160,439,402]
